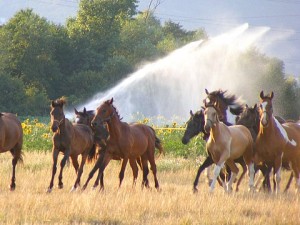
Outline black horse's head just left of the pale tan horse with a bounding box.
[182,109,209,145]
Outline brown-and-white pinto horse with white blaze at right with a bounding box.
[254,91,300,193]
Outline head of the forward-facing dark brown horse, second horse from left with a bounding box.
[50,98,66,132]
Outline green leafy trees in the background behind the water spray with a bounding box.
[0,0,300,119]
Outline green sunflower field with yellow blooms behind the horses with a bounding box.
[22,117,206,158]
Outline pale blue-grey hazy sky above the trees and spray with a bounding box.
[0,0,300,77]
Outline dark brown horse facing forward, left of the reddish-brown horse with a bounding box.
[47,98,96,193]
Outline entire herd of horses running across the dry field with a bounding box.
[0,89,300,193]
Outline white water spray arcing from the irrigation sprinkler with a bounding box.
[67,24,290,122]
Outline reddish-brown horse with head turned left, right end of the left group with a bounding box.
[83,98,164,190]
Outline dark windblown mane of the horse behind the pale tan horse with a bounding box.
[209,89,244,115]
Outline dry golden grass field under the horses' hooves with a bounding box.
[0,153,300,225]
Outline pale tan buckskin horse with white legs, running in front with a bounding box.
[204,103,254,192]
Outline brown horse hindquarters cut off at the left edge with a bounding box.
[0,113,23,191]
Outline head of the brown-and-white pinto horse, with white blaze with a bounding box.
[259,91,274,127]
